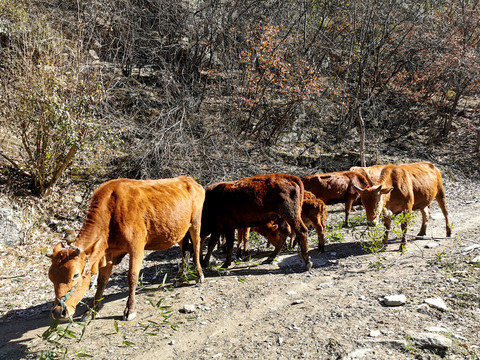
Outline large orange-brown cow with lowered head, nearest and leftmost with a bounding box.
[48,176,205,320]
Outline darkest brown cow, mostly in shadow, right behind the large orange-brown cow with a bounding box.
[201,174,312,270]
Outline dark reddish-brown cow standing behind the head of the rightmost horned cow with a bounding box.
[302,171,371,226]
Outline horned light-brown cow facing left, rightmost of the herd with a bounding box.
[356,162,451,249]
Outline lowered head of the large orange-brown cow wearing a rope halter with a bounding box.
[48,243,91,320]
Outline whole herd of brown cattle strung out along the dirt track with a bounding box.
[49,162,451,320]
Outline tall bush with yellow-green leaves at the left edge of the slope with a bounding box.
[0,8,102,196]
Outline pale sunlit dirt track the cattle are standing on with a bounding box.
[0,178,480,360]
